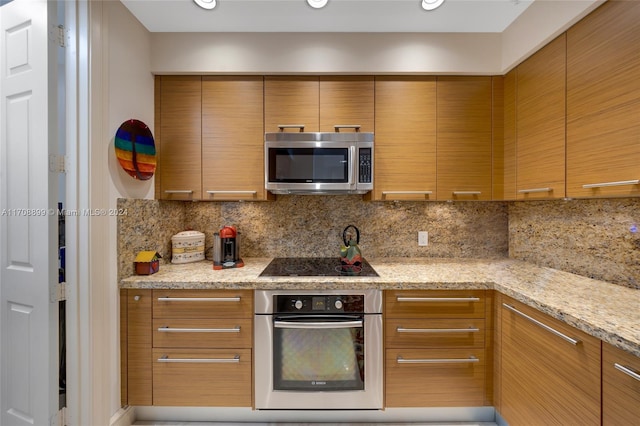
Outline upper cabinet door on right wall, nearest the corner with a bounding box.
[516,34,566,199]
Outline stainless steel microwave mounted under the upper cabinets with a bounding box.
[264,132,374,194]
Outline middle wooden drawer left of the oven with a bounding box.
[153,318,252,349]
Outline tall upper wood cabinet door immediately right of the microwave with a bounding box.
[372,77,436,200]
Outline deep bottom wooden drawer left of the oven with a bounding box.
[153,349,251,407]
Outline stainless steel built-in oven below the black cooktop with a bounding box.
[254,290,383,410]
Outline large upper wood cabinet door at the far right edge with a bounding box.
[567,1,640,197]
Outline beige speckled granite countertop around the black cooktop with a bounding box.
[120,258,640,357]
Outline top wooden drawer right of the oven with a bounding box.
[384,290,485,318]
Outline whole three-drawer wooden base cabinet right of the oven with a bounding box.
[384,290,492,407]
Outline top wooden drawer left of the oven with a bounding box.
[153,290,253,318]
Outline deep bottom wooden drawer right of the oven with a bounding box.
[385,349,486,407]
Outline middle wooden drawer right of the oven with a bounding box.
[385,318,485,348]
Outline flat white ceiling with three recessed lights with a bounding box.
[121,0,540,33]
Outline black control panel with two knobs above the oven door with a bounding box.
[274,294,364,314]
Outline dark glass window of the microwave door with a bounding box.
[269,148,349,183]
